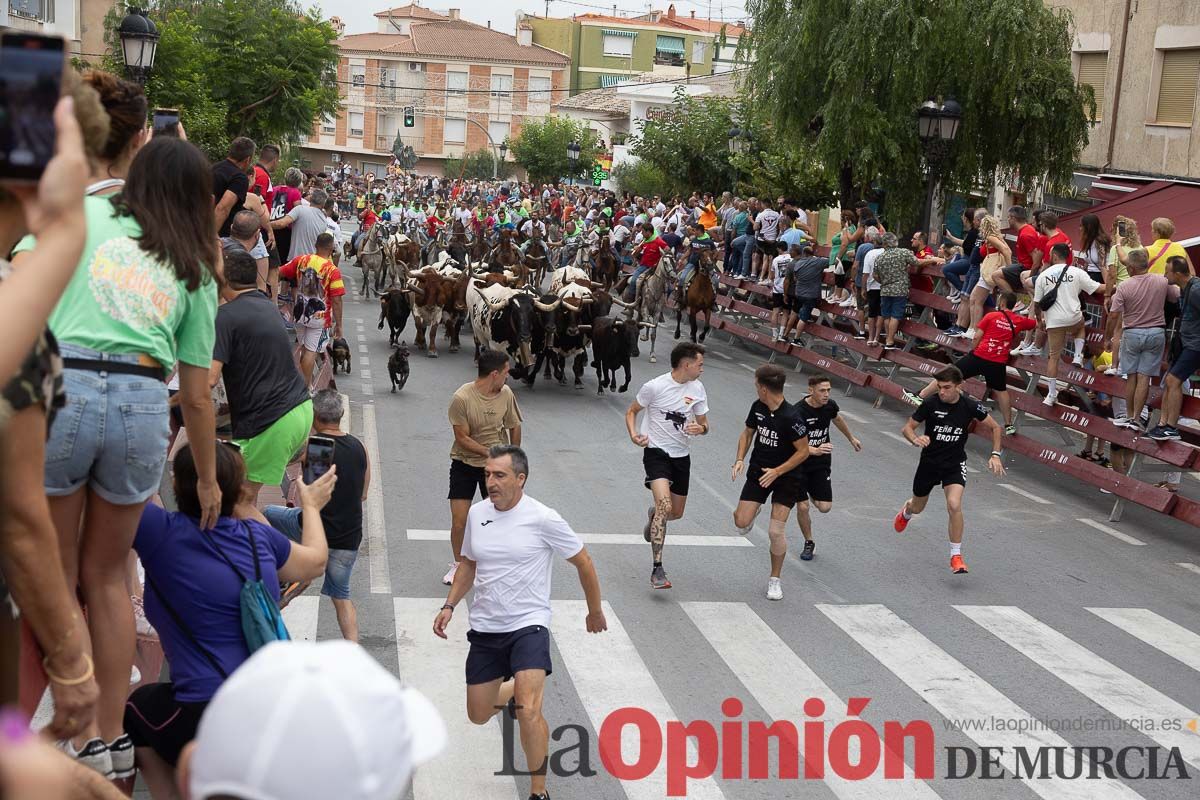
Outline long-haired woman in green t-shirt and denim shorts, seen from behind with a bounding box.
[13,137,221,776]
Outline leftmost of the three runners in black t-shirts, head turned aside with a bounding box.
[732,363,809,600]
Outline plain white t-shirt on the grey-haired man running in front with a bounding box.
[462,494,583,633]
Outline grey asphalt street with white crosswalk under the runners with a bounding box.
[284,266,1200,800]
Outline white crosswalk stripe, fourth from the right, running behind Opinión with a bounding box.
[680,602,937,800]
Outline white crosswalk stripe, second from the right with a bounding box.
[955,606,1200,765]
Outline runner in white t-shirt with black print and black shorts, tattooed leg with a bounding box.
[625,342,708,589]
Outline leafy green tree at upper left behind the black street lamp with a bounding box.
[106,0,340,160]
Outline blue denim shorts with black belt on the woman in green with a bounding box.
[43,343,170,505]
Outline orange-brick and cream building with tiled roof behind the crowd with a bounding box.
[301,5,570,174]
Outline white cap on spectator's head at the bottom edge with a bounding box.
[190,639,446,800]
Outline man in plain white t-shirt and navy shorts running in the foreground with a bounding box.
[433,445,608,800]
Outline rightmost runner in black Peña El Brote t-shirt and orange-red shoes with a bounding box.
[893,367,1004,575]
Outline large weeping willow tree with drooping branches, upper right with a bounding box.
[738,0,1094,227]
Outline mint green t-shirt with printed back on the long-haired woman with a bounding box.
[13,197,217,377]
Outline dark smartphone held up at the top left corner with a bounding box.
[0,31,66,181]
